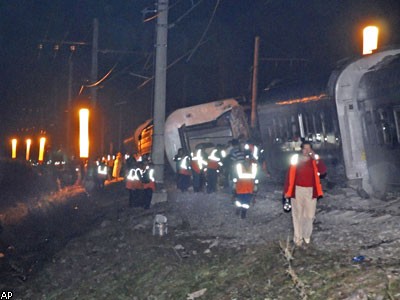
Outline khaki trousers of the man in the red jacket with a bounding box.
[292,185,317,244]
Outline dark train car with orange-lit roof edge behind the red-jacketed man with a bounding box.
[257,76,342,177]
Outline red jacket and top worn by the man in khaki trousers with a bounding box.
[283,154,327,198]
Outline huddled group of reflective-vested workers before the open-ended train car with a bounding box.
[174,139,268,218]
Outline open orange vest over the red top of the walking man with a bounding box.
[284,154,324,198]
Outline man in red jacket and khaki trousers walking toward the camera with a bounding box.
[284,141,327,247]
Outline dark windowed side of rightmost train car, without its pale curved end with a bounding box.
[357,54,400,191]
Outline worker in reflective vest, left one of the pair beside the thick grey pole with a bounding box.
[125,162,143,207]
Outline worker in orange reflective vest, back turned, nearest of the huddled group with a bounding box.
[233,152,258,219]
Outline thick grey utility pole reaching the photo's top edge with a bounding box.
[152,0,168,184]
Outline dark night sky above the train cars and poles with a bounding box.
[0,0,400,155]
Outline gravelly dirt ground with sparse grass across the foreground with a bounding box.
[0,179,400,299]
